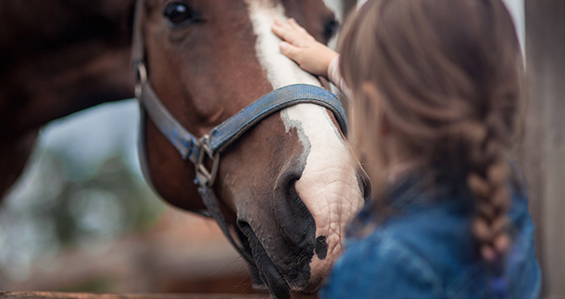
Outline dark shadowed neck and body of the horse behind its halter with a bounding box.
[0,0,135,196]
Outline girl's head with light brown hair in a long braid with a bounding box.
[340,0,522,260]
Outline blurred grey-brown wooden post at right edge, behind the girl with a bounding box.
[520,0,565,298]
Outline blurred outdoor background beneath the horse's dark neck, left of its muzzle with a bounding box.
[0,100,252,293]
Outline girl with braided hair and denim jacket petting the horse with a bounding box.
[272,0,541,298]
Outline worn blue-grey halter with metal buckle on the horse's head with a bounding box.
[132,0,347,265]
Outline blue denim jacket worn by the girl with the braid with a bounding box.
[320,168,541,299]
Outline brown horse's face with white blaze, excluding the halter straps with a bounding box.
[143,0,363,297]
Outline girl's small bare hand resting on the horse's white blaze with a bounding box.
[271,19,338,78]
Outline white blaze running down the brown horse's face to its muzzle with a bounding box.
[247,0,363,279]
